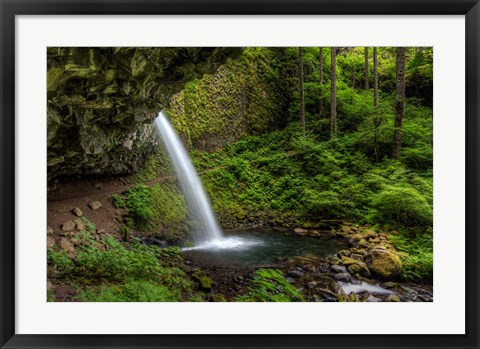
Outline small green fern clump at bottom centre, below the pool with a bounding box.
[236,269,304,302]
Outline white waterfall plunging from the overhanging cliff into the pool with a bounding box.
[155,112,225,248]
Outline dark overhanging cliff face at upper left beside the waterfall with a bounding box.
[47,47,241,180]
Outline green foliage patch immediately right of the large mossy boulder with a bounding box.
[388,234,433,281]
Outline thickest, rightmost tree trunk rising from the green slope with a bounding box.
[392,47,406,159]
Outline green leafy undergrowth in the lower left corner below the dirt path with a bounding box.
[48,230,204,302]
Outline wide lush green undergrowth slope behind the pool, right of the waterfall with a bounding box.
[191,119,433,232]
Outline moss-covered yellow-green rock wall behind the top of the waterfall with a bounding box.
[167,47,291,150]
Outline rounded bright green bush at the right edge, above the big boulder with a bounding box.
[371,186,433,227]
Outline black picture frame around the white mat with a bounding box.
[0,0,480,349]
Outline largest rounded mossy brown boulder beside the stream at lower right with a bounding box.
[365,249,403,280]
